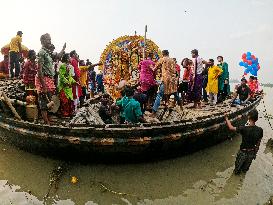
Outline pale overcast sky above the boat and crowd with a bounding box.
[0,0,273,82]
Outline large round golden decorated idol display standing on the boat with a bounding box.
[100,35,161,99]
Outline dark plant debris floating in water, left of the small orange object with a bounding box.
[44,162,68,199]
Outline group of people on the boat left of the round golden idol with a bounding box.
[0,31,104,124]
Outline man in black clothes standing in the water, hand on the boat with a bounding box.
[225,109,263,175]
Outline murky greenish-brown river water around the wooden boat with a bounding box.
[0,88,273,205]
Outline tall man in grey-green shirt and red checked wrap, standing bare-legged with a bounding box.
[35,33,55,125]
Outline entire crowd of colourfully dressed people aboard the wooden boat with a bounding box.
[0,31,261,124]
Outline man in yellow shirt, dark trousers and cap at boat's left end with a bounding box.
[9,31,23,78]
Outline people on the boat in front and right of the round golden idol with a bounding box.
[98,49,261,123]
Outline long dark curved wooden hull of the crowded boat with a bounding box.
[0,80,261,161]
